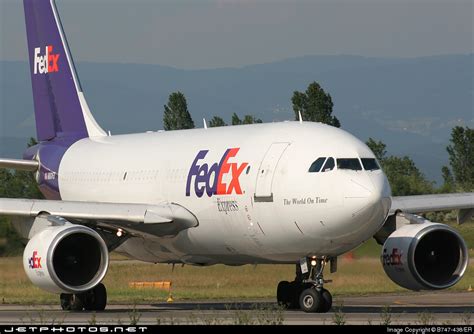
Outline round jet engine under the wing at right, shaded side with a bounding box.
[380,222,469,290]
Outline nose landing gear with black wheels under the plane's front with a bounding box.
[277,258,332,313]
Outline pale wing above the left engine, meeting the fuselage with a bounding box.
[0,198,199,237]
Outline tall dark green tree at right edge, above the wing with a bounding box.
[442,126,474,191]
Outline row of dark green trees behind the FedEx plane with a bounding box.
[0,82,474,255]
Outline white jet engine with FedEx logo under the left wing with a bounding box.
[23,224,109,293]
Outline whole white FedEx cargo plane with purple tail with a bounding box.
[0,0,474,312]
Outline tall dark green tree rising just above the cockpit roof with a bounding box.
[291,81,341,128]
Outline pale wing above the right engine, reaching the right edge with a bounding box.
[390,193,474,224]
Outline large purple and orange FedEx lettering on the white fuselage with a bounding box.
[186,148,248,197]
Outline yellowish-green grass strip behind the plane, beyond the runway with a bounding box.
[0,257,474,304]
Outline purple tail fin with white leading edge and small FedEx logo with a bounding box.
[23,0,105,141]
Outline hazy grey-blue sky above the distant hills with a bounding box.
[0,0,474,69]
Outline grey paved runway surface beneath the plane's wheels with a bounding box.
[0,292,474,325]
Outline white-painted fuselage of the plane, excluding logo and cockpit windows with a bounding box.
[59,122,390,264]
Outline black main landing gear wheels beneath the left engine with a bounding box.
[59,283,107,311]
